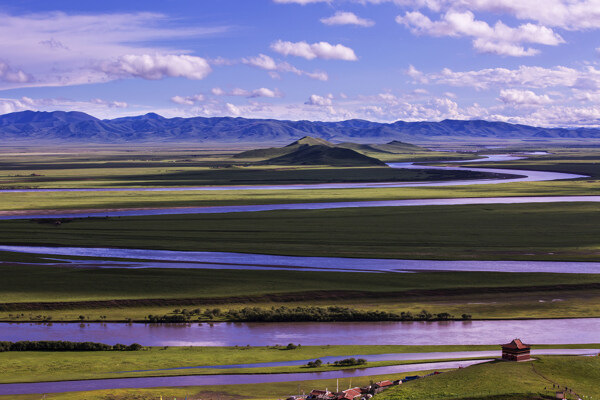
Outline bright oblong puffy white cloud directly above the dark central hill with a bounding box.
[271,40,358,61]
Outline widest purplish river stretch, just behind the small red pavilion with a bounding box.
[0,318,600,346]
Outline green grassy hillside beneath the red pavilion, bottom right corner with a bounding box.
[375,356,600,400]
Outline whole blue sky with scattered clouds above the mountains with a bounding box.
[0,0,600,126]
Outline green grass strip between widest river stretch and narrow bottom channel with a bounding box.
[0,344,600,383]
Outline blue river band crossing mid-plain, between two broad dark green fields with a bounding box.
[0,245,600,274]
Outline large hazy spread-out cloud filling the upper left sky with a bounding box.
[0,12,229,89]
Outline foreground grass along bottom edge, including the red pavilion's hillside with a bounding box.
[0,356,600,400]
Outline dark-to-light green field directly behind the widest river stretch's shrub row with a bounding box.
[0,265,600,321]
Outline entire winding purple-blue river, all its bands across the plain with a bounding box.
[0,155,600,395]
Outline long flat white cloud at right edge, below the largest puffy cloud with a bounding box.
[407,66,600,90]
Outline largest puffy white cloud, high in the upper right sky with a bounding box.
[396,11,564,56]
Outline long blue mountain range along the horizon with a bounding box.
[0,111,600,144]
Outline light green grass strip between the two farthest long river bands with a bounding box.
[0,179,600,214]
